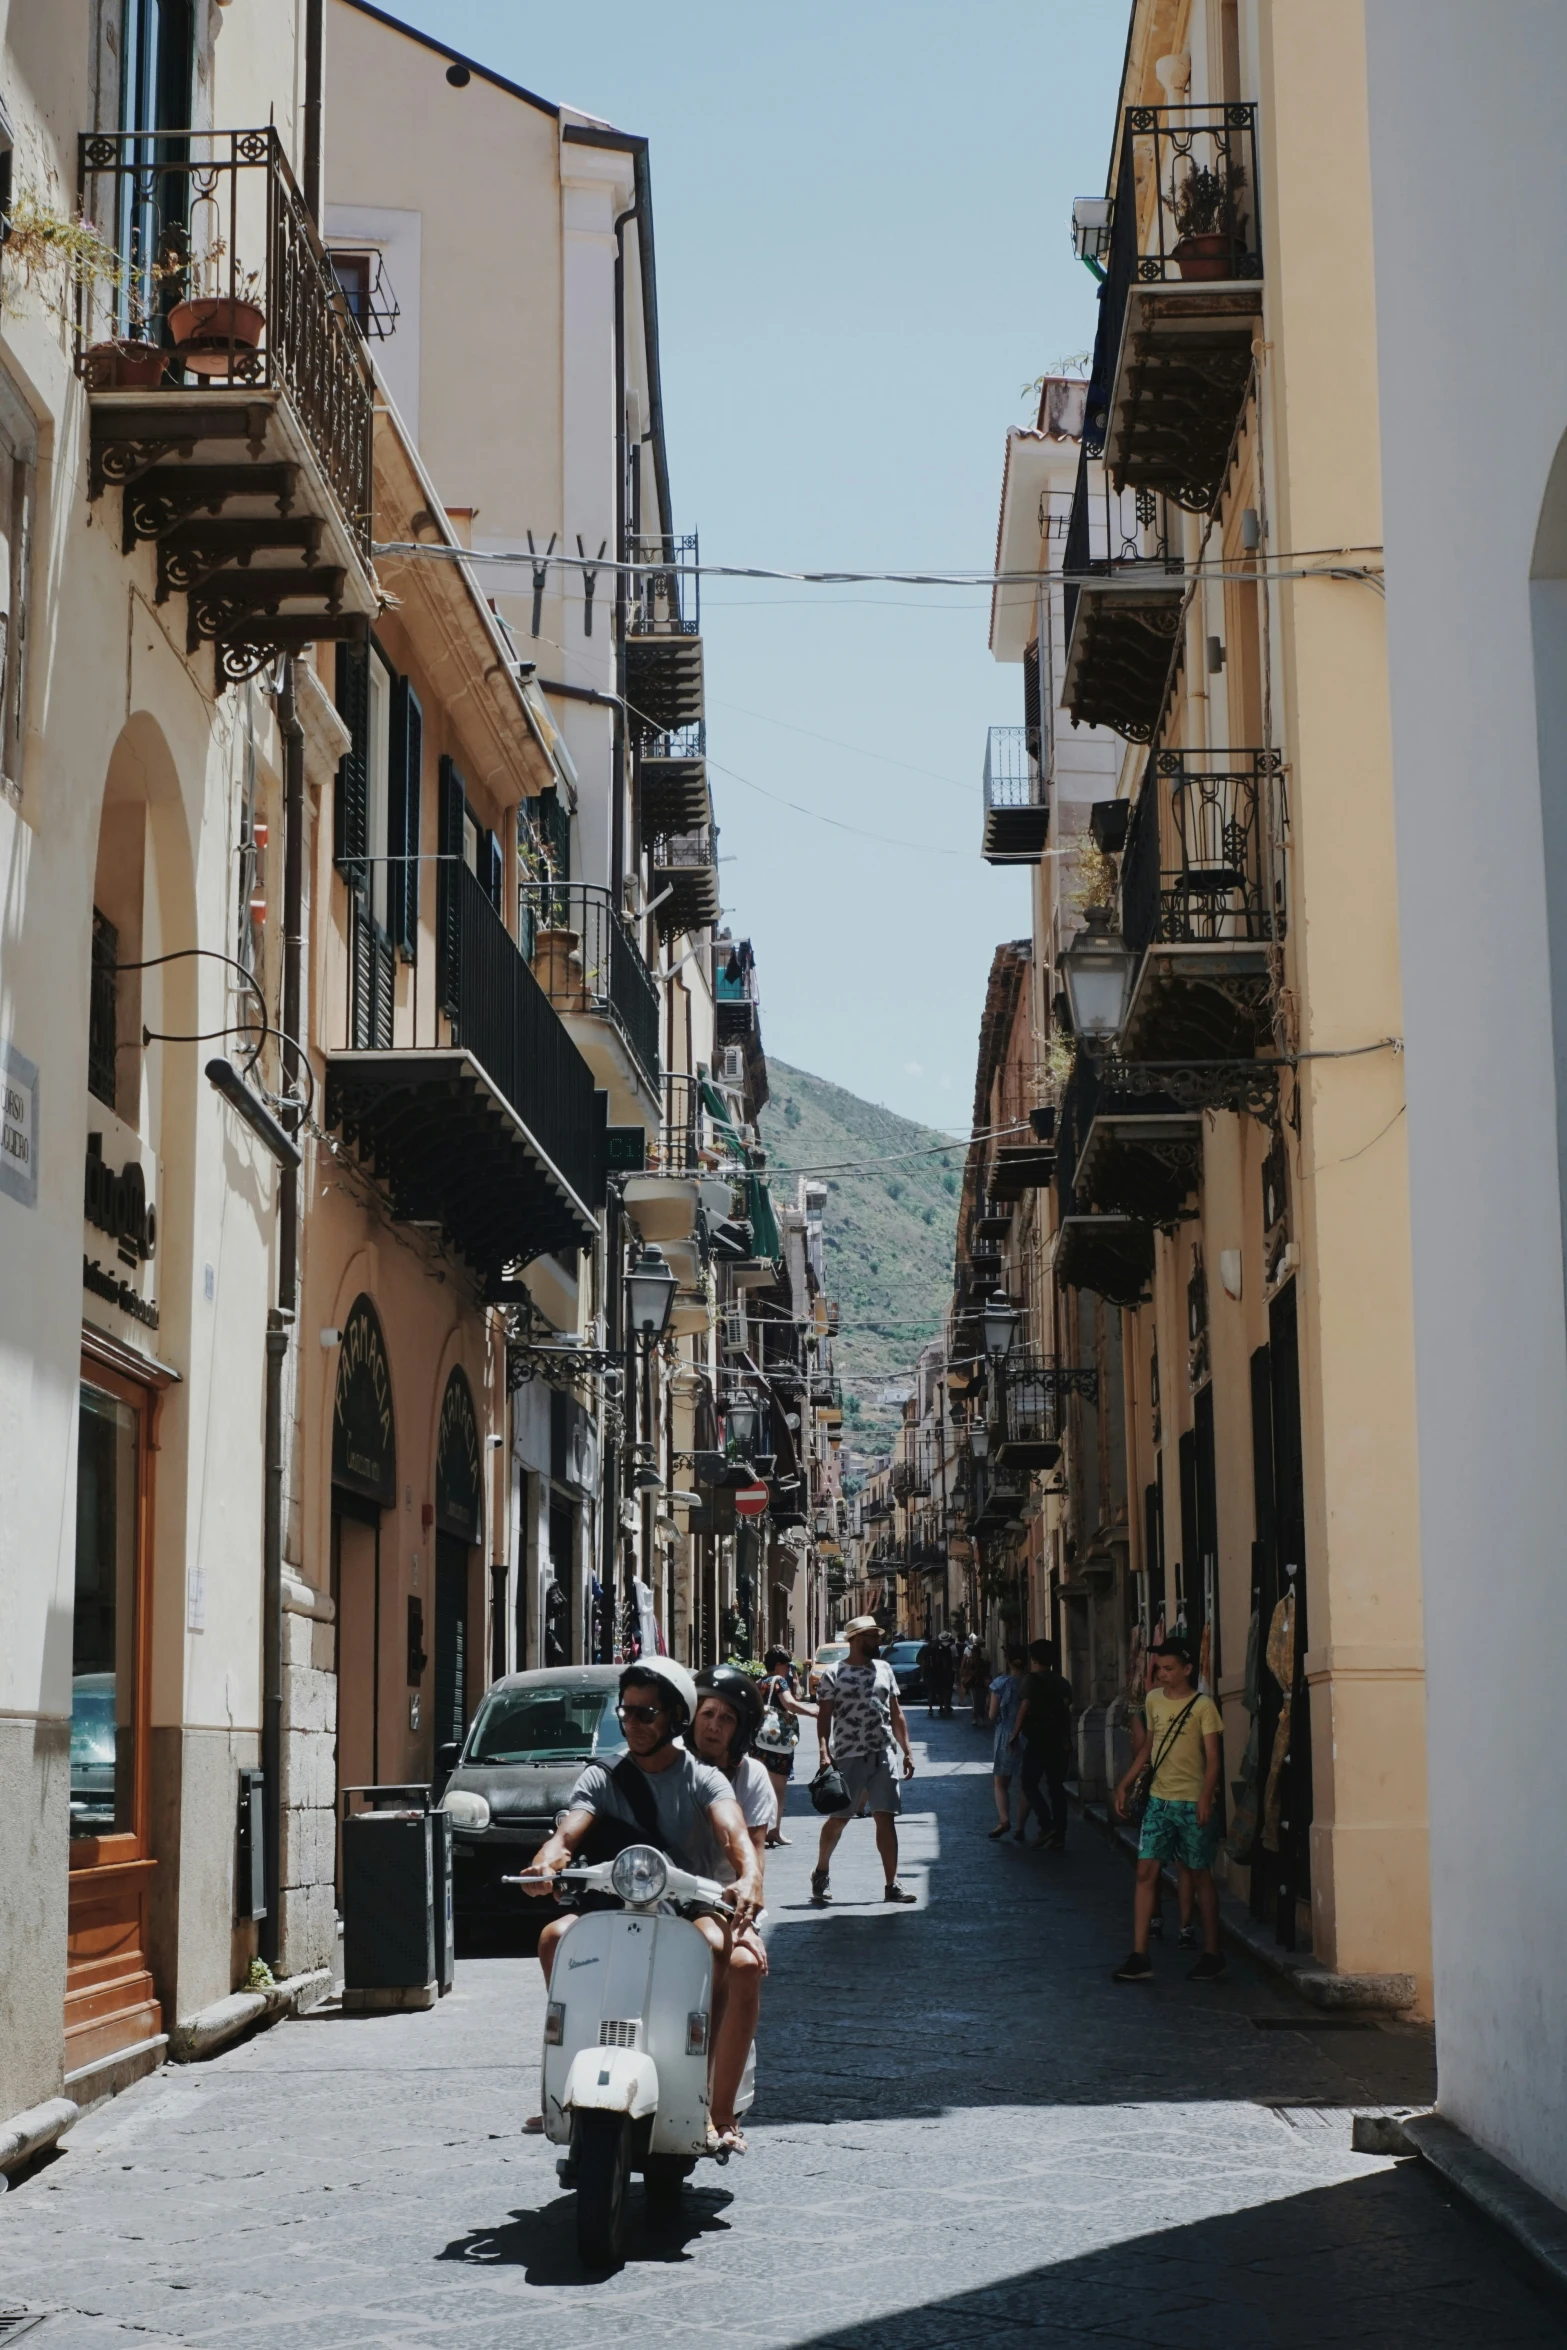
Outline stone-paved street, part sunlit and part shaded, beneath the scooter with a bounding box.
[0,1713,1567,2350]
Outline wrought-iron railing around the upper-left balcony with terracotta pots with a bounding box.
[75,125,374,564]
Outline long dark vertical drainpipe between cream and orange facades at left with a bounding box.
[261,660,305,1965]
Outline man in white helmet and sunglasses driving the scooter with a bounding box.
[526,1657,761,2153]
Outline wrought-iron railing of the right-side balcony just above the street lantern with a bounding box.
[1121,750,1285,947]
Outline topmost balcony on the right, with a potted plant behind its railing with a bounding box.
[1083,103,1262,515]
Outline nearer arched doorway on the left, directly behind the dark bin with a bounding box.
[331,1295,397,1788]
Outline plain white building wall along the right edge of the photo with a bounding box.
[1367,0,1567,2202]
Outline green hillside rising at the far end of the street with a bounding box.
[761,1055,963,1450]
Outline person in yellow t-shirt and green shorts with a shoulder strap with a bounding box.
[1114,1638,1224,1983]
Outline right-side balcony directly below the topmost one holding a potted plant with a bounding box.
[1062,449,1184,743]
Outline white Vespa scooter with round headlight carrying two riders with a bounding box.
[505,1845,756,2268]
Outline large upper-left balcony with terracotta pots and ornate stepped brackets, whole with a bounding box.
[75,127,376,693]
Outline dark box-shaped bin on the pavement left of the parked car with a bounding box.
[343,1786,434,2012]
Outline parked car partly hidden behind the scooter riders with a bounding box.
[437,1664,625,1920]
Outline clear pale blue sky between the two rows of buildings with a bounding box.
[383,0,1128,1130]
